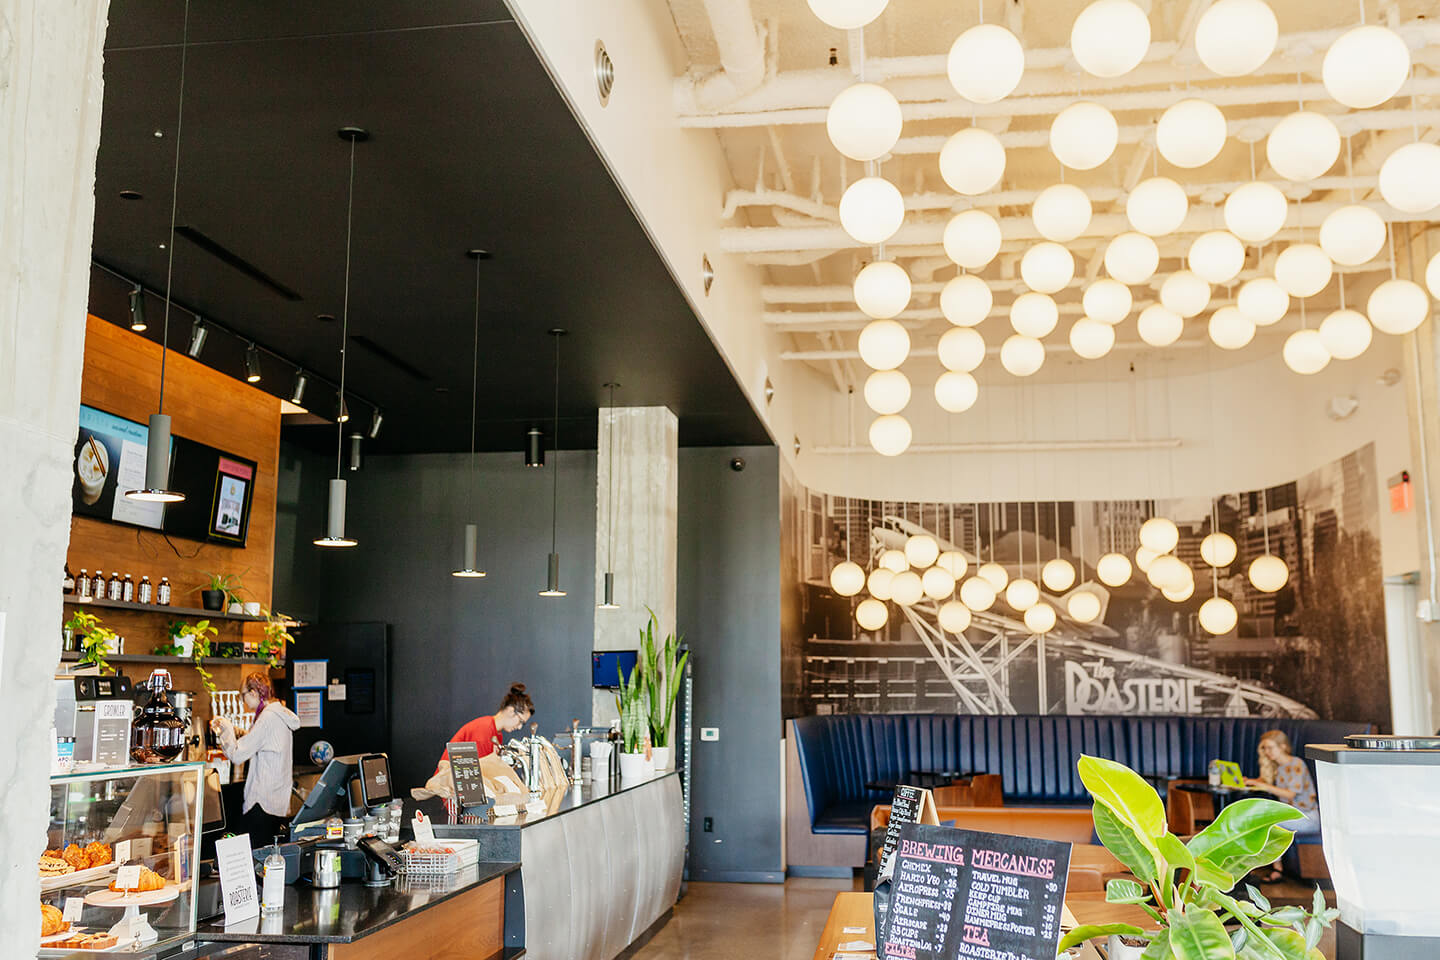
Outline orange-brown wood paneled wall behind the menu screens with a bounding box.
[67,315,279,616]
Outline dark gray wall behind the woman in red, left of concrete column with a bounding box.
[296,450,596,789]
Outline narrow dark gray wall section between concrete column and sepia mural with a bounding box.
[677,446,785,881]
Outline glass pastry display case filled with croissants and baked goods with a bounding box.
[37,763,205,957]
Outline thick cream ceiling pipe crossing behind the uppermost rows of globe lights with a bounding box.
[674,22,1440,127]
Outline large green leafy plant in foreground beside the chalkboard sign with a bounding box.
[1060,756,1339,960]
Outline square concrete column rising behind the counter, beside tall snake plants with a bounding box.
[592,407,680,724]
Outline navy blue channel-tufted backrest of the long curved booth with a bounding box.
[792,714,1371,823]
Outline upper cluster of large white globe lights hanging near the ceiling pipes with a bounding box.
[808,0,1440,456]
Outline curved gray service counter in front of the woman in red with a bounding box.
[435,773,685,960]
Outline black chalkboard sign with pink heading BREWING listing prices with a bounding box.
[877,823,1070,960]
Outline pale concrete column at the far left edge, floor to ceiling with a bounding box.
[0,0,109,957]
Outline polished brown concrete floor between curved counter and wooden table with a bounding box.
[632,878,1335,960]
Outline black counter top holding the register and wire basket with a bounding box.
[196,862,520,943]
